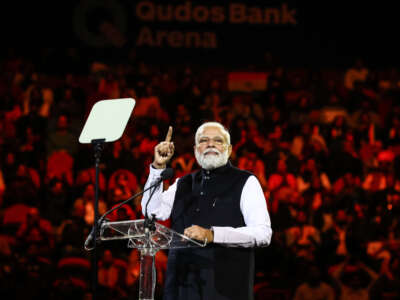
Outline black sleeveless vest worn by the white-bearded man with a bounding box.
[164,163,254,300]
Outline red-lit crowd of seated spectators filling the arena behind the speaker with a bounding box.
[0,49,400,300]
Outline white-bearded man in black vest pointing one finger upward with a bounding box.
[142,122,272,300]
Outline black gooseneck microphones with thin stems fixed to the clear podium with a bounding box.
[84,168,174,251]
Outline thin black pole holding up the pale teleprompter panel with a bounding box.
[92,139,105,300]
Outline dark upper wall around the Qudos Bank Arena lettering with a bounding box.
[1,0,400,67]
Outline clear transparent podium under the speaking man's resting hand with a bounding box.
[99,220,206,300]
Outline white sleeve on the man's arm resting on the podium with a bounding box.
[213,176,272,247]
